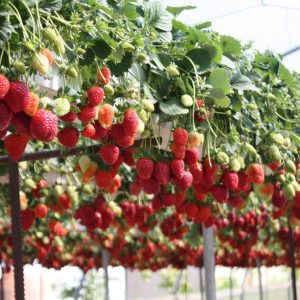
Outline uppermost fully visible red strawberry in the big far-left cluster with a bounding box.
[4,80,30,113]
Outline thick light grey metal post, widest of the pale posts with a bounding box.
[202,225,217,300]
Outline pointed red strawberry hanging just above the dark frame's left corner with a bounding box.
[4,133,29,161]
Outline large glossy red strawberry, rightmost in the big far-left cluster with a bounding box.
[30,110,58,142]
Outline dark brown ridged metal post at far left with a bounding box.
[9,163,25,300]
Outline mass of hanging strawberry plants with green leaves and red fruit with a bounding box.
[0,0,300,270]
